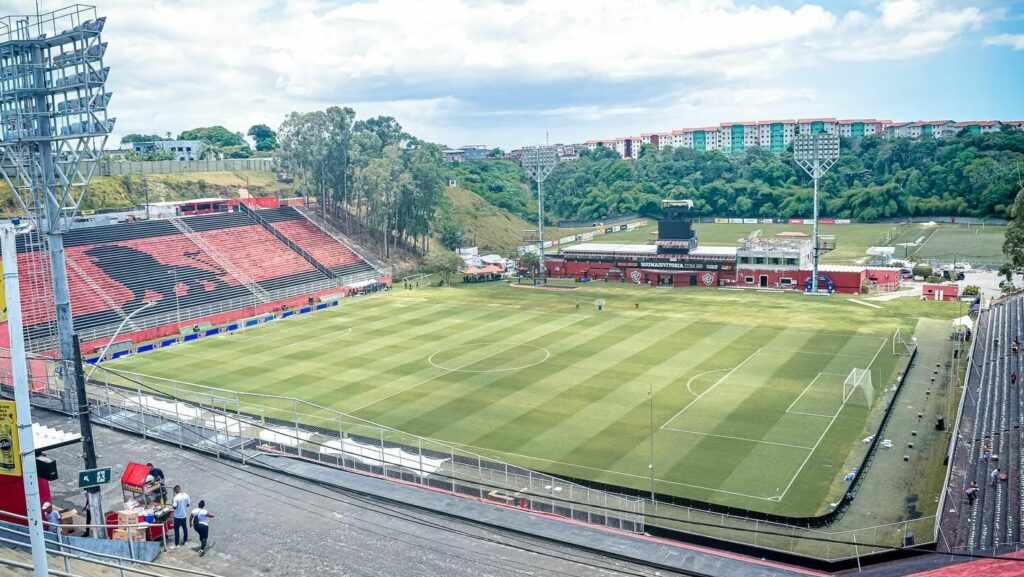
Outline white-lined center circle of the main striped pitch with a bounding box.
[427,342,551,373]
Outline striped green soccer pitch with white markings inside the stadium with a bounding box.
[109,283,955,516]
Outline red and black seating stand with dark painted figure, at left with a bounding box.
[6,208,378,350]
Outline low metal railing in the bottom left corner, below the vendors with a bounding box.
[0,510,224,577]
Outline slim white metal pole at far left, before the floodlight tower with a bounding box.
[0,224,49,577]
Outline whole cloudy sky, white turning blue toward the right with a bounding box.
[8,0,1024,148]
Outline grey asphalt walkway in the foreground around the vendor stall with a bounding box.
[34,410,688,577]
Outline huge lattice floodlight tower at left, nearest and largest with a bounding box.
[0,4,114,397]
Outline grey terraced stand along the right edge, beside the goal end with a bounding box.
[943,296,1024,550]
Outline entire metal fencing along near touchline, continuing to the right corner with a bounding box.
[75,362,936,561]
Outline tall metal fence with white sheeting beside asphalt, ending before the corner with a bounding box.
[87,366,645,532]
